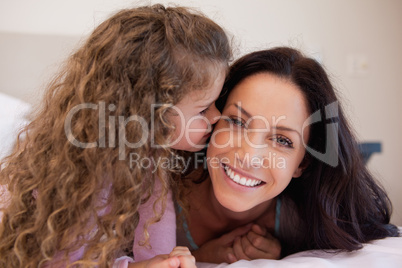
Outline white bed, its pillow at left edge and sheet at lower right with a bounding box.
[0,92,402,268]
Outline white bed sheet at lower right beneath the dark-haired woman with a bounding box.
[197,231,402,268]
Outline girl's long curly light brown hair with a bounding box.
[0,5,231,267]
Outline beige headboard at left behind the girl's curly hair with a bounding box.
[0,32,80,104]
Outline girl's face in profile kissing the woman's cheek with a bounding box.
[170,68,226,152]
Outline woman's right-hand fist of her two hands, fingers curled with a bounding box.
[233,224,281,260]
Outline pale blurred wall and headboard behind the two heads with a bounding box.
[0,0,402,226]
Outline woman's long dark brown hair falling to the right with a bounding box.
[216,47,399,255]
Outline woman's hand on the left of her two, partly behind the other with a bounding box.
[193,224,251,263]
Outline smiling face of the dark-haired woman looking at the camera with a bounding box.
[207,73,309,212]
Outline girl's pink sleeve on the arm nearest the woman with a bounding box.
[133,180,176,261]
